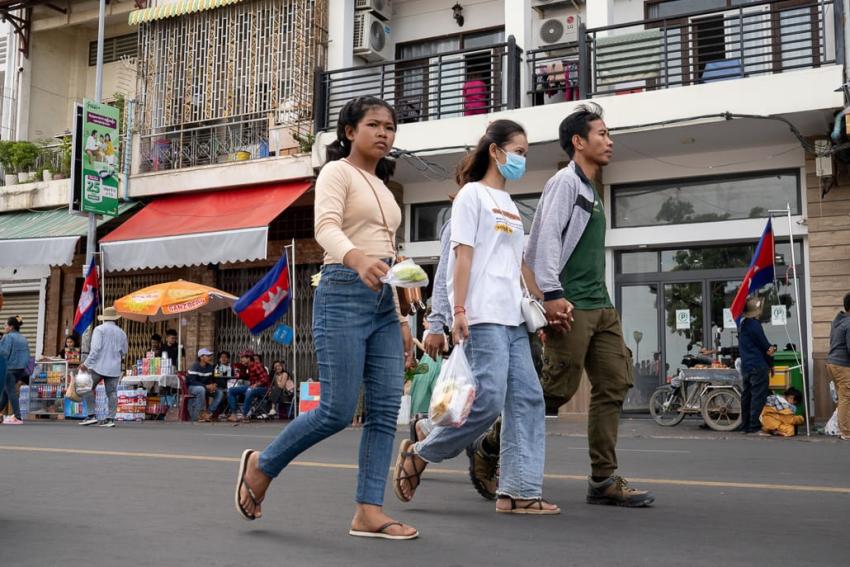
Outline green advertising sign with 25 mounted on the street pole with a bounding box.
[78,100,119,217]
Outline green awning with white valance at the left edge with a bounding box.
[0,203,138,268]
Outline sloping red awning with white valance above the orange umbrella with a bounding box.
[100,180,312,271]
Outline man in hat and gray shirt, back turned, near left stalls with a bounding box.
[80,307,129,427]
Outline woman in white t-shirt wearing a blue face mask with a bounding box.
[394,120,560,514]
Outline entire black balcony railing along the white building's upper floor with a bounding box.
[314,0,844,131]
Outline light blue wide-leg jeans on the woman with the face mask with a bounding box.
[414,324,546,499]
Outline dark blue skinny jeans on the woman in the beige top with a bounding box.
[260,264,404,506]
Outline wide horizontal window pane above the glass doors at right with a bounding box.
[611,170,801,228]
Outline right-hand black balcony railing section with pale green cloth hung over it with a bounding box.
[579,0,843,97]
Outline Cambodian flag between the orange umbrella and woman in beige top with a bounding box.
[233,252,292,335]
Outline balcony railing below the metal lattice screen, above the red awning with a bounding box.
[139,116,269,173]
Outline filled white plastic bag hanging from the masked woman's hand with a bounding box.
[428,342,478,427]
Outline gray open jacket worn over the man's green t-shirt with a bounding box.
[525,161,596,301]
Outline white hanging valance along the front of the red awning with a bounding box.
[100,227,269,272]
